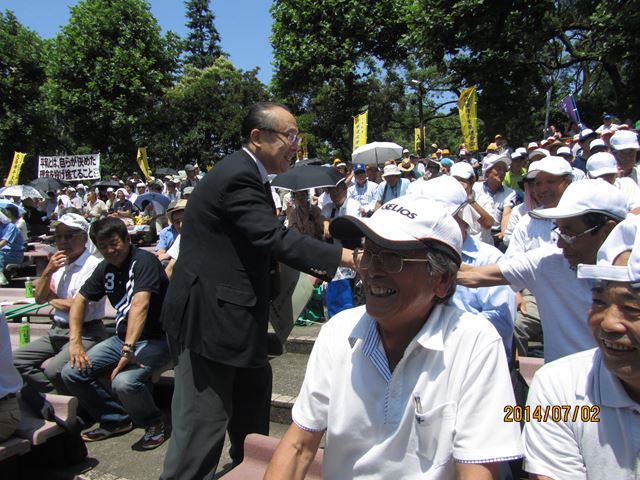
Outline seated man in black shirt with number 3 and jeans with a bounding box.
[62,217,169,449]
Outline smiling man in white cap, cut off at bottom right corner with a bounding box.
[524,216,640,480]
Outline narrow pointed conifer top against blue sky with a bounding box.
[184,0,223,68]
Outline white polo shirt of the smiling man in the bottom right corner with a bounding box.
[524,348,640,480]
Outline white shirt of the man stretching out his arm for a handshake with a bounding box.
[498,245,596,362]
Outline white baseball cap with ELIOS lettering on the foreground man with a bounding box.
[329,194,462,265]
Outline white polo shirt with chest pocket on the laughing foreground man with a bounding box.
[292,305,522,479]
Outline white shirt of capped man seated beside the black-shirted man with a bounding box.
[50,248,106,325]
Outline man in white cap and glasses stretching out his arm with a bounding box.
[458,180,628,362]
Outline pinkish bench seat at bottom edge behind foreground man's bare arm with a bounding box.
[220,433,324,480]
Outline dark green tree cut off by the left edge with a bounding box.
[0,10,51,181]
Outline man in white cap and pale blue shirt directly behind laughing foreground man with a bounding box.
[416,174,516,358]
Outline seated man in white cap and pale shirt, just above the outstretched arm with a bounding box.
[473,153,515,245]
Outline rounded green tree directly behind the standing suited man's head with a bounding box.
[149,56,267,168]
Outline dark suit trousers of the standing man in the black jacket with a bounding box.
[160,338,272,480]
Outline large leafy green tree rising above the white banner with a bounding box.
[49,0,179,171]
